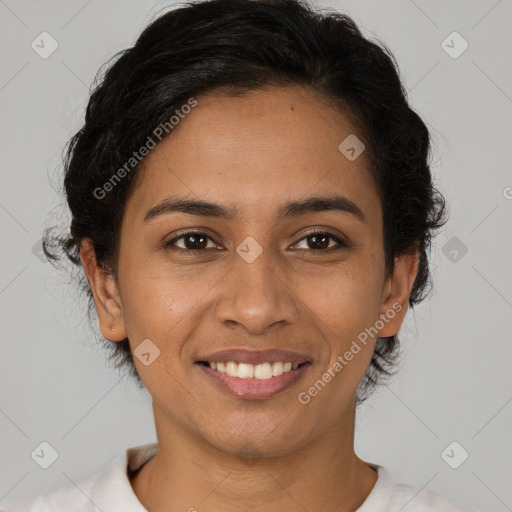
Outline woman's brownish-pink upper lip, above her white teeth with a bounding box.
[197,348,310,364]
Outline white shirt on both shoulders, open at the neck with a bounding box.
[8,443,470,512]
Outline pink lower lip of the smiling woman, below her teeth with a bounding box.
[197,363,311,400]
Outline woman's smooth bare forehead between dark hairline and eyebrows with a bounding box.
[123,87,380,225]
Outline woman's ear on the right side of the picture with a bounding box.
[378,249,419,338]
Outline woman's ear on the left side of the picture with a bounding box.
[80,240,127,341]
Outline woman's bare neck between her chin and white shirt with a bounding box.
[131,404,377,512]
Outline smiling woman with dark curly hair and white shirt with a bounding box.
[8,0,474,512]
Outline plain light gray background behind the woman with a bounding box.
[0,0,512,512]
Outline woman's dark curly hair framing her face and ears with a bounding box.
[43,0,447,403]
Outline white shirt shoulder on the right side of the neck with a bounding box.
[357,465,472,512]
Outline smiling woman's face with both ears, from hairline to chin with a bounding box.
[82,87,417,455]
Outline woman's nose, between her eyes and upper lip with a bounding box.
[215,250,299,335]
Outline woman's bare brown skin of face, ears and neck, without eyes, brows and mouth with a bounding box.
[81,87,418,512]
